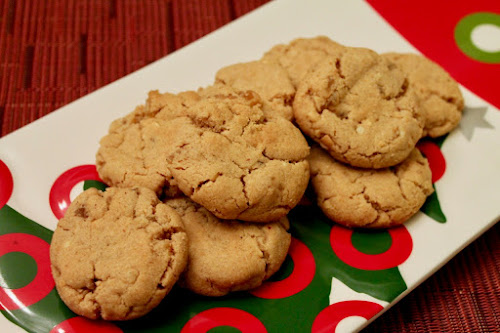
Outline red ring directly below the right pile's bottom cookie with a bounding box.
[330,225,413,270]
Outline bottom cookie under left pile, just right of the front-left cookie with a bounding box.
[166,198,291,296]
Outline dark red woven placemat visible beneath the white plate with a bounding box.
[0,0,500,332]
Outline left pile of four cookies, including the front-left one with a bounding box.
[51,83,310,320]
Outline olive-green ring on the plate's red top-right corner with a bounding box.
[455,12,500,64]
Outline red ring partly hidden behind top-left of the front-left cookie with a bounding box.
[49,164,102,219]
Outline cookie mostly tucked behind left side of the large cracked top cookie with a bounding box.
[96,91,198,197]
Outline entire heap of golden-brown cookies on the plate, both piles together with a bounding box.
[51,37,463,320]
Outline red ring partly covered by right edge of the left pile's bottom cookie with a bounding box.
[250,237,316,299]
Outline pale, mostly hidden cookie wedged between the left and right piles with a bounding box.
[215,61,295,120]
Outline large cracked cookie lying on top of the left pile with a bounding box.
[154,85,309,222]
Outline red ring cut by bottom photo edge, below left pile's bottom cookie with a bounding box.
[181,308,267,333]
